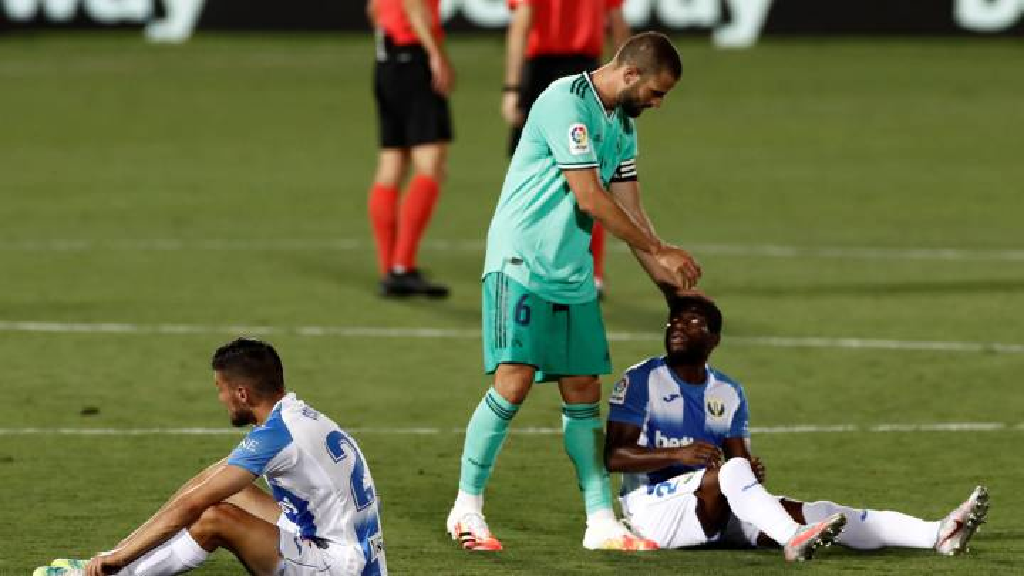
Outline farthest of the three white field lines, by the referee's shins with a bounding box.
[0,238,1024,262]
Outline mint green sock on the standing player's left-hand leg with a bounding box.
[459,387,519,495]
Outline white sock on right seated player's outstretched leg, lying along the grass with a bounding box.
[804,501,939,550]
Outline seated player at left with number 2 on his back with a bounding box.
[33,338,387,576]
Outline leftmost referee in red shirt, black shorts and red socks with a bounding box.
[367,0,455,298]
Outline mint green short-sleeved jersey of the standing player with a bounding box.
[483,73,637,304]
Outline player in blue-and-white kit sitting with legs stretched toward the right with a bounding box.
[604,291,988,561]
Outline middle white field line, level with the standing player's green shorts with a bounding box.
[0,320,1024,354]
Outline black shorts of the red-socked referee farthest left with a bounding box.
[374,41,452,148]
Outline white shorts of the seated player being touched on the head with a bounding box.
[618,470,758,548]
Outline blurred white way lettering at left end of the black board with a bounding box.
[0,0,206,42]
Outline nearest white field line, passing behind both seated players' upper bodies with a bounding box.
[0,422,1024,437]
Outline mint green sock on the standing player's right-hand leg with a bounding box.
[562,403,611,517]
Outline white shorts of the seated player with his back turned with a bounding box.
[275,515,366,576]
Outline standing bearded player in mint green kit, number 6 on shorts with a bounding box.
[446,33,700,549]
